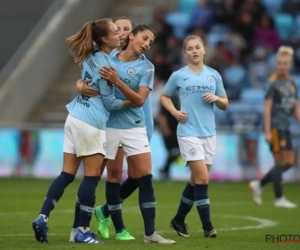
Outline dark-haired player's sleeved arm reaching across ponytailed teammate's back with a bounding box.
[99,67,154,107]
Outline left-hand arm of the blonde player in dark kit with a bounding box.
[264,82,275,142]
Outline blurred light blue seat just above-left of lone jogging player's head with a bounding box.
[166,12,191,39]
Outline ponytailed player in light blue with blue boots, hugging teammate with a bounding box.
[32,19,132,244]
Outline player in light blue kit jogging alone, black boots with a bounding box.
[161,36,228,237]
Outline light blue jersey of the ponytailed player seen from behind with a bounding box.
[66,51,124,130]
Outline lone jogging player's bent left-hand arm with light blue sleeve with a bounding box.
[160,73,188,122]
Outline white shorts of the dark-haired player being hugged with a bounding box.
[105,127,151,160]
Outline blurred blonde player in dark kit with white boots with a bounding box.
[249,46,300,208]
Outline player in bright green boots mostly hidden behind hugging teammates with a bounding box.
[75,17,153,241]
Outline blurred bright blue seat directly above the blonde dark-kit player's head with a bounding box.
[274,13,294,41]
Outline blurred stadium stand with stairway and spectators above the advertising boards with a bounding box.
[0,0,300,128]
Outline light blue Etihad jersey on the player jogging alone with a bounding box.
[163,66,226,137]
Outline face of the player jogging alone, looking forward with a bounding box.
[184,37,205,64]
